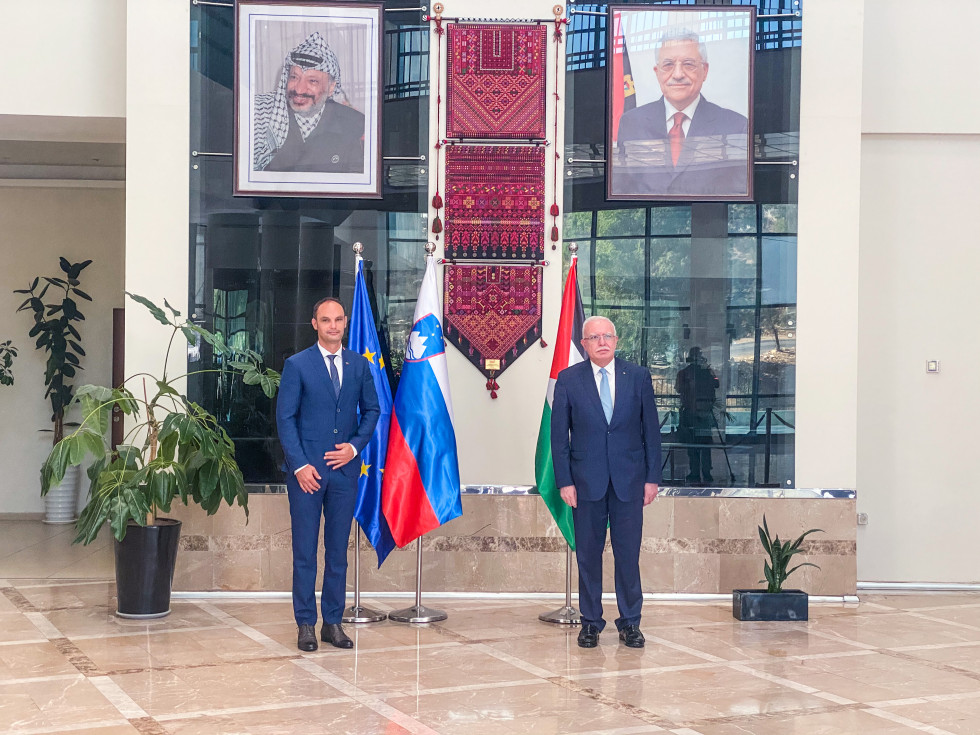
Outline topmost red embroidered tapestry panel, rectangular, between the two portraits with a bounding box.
[446,23,548,139]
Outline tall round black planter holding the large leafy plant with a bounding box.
[115,518,181,618]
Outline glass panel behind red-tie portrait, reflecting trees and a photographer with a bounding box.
[565,0,802,494]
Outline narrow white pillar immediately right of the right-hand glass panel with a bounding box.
[796,0,864,488]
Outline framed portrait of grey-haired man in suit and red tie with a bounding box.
[606,5,756,201]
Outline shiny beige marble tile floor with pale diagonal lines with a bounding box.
[0,521,980,735]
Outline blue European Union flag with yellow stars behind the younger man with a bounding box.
[348,256,395,567]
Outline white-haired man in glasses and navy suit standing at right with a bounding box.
[551,316,660,648]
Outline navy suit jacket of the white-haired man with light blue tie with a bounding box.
[551,358,660,501]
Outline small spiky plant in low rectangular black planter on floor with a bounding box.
[732,515,823,620]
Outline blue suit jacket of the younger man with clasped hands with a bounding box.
[276,344,381,478]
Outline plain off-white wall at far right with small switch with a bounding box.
[857,0,980,583]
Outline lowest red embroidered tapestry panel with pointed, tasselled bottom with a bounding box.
[443,265,541,378]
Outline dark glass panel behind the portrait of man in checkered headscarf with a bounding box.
[188,0,430,484]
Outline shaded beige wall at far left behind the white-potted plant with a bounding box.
[0,187,125,514]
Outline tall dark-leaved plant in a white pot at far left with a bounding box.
[14,258,92,523]
